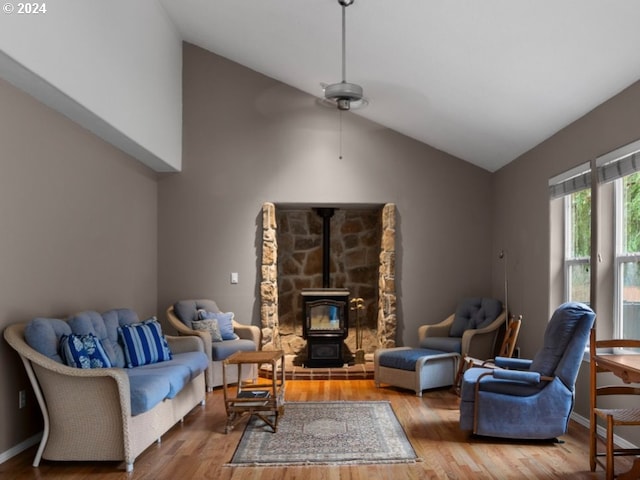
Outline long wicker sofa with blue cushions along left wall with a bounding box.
[4,309,208,472]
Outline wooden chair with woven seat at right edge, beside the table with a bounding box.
[589,328,640,480]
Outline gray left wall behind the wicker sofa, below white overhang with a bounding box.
[0,81,157,453]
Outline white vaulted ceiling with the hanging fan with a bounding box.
[160,0,640,171]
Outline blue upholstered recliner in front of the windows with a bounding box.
[460,303,596,440]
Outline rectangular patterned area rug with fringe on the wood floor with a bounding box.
[229,402,418,466]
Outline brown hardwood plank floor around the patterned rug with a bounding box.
[0,380,620,480]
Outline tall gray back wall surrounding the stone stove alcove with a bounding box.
[158,45,492,345]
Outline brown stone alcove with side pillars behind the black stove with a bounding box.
[260,203,396,357]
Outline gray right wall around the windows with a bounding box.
[492,82,640,436]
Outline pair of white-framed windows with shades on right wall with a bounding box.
[549,140,640,339]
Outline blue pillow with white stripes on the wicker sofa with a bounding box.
[118,317,172,368]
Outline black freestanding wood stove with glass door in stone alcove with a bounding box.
[302,288,349,368]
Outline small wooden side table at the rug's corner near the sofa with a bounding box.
[222,350,285,433]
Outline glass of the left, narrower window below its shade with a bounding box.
[564,189,591,304]
